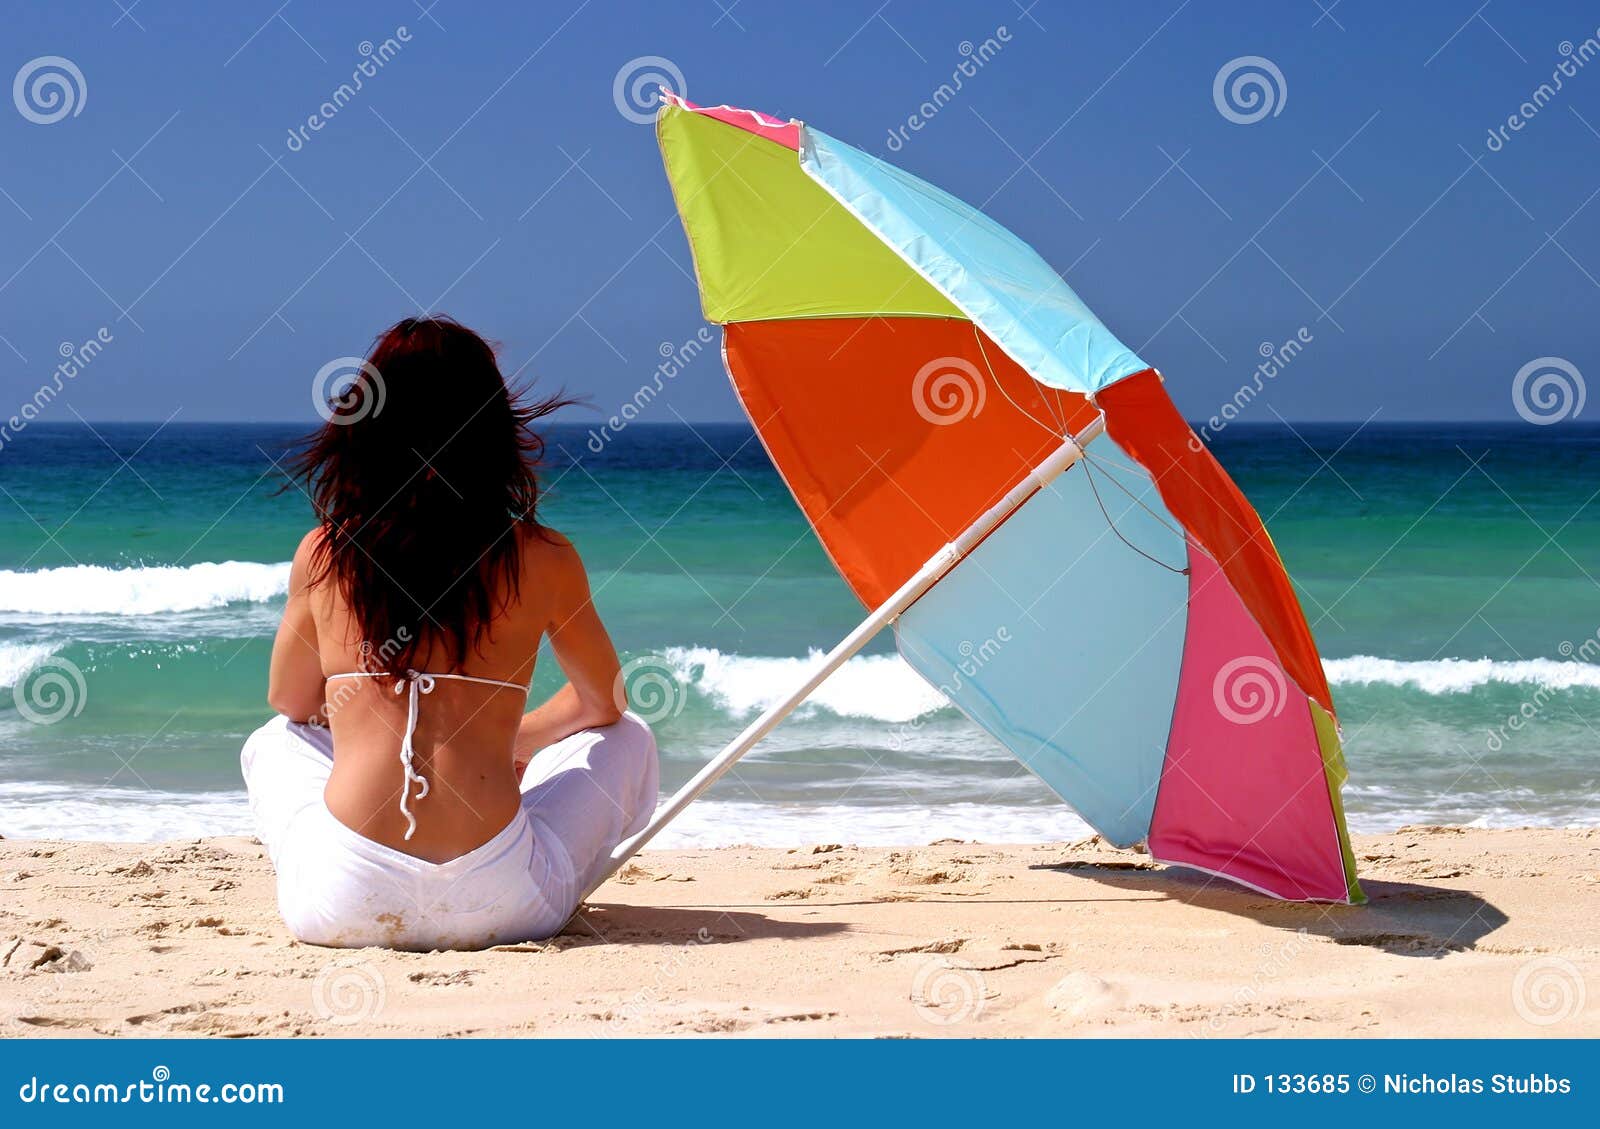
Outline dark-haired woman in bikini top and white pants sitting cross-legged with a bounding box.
[242,318,658,950]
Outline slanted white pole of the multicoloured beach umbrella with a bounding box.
[579,416,1106,900]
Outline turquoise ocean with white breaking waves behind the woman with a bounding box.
[0,422,1600,846]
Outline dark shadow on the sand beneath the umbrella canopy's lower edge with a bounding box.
[1030,862,1507,959]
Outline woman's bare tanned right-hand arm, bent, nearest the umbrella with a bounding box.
[515,533,627,771]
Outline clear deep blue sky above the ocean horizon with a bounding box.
[0,0,1600,422]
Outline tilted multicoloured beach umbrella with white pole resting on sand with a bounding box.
[595,93,1363,902]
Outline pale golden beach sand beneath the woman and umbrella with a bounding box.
[0,827,1600,1038]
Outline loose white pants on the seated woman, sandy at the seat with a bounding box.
[240,713,658,951]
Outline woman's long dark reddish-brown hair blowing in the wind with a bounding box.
[291,317,573,678]
